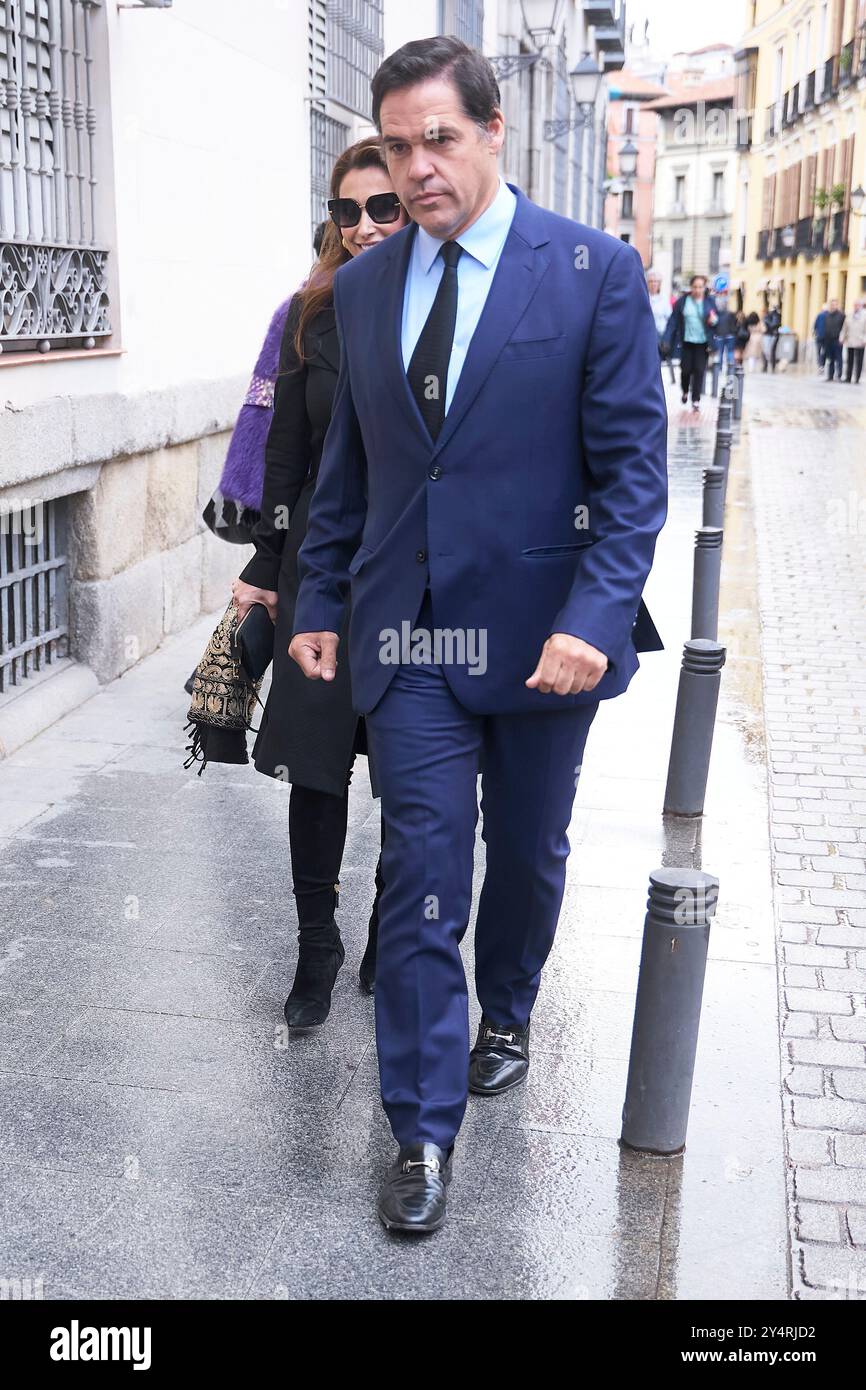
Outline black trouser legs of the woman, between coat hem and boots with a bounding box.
[289,770,385,940]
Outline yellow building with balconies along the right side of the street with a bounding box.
[731,0,866,350]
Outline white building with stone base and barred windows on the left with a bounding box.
[0,0,624,756]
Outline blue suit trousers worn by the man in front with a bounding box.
[366,595,599,1148]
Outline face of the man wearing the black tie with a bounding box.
[379,78,505,240]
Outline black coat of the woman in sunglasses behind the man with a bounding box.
[240,296,366,796]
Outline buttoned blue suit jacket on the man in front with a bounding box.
[293,185,667,713]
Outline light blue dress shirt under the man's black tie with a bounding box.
[402,178,517,414]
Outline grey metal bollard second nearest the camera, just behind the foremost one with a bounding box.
[664,637,726,816]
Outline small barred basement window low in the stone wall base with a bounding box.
[0,498,68,695]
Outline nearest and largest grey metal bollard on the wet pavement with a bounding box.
[620,869,719,1154]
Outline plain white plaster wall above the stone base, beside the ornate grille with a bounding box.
[0,0,311,407]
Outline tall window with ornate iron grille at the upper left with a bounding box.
[0,0,111,352]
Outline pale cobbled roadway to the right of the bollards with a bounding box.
[744,374,866,1301]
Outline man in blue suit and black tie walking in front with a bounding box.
[291,38,667,1232]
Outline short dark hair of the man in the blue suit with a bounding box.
[370,35,500,133]
